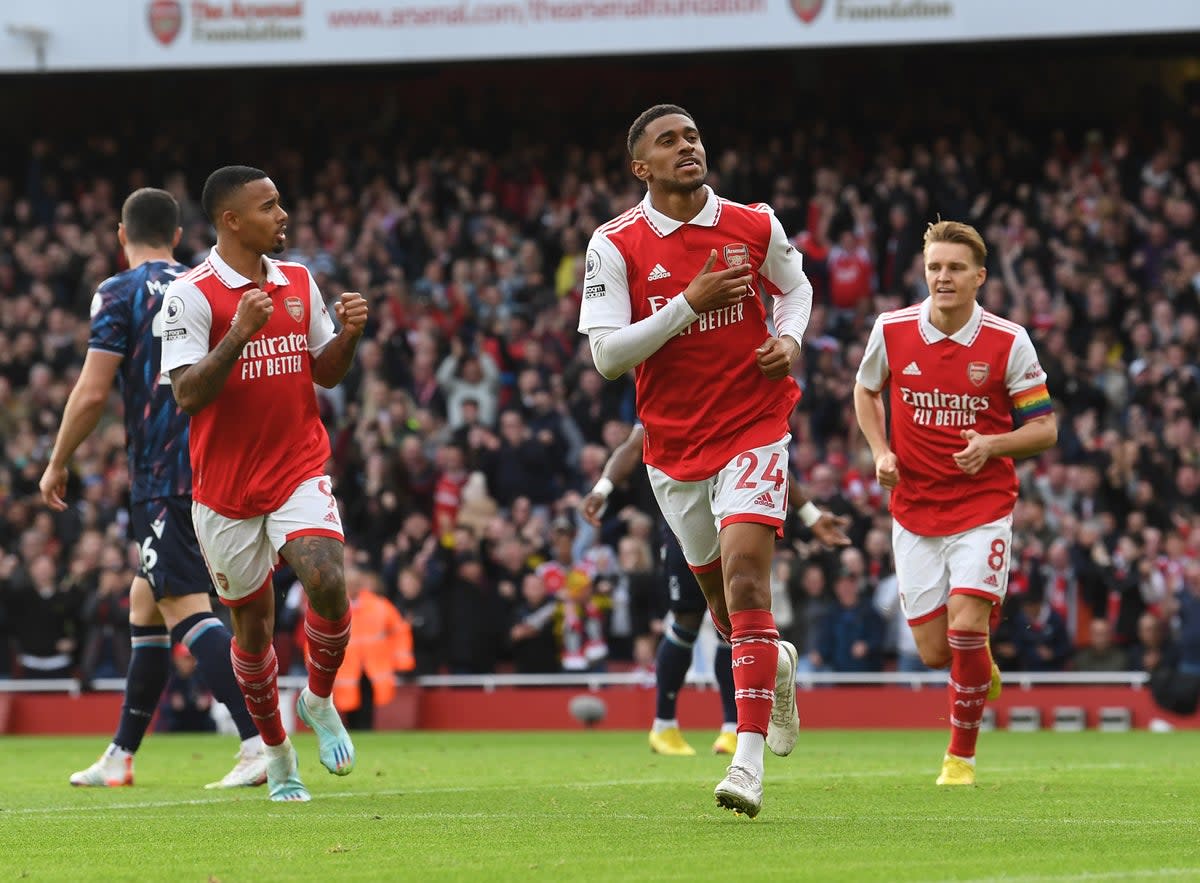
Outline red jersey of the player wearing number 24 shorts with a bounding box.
[580,187,805,481]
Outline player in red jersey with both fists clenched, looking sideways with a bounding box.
[162,166,367,800]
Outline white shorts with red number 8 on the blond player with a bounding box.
[892,516,1013,625]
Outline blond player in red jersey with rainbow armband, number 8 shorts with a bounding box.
[854,221,1058,785]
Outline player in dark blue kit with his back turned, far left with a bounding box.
[41,187,266,788]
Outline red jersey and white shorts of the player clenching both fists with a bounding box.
[162,248,342,602]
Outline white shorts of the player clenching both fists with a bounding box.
[192,475,343,607]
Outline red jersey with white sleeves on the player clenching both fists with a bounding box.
[162,248,334,518]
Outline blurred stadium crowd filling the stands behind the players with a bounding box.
[0,74,1200,680]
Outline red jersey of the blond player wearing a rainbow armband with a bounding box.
[858,299,1051,536]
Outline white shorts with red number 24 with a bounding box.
[646,434,792,573]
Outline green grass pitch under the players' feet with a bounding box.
[0,729,1200,883]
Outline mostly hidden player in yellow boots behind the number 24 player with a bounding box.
[580,424,850,757]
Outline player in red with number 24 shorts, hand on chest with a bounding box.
[580,104,812,817]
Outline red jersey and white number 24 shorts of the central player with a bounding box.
[580,187,811,570]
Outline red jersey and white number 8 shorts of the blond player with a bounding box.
[857,299,1051,625]
